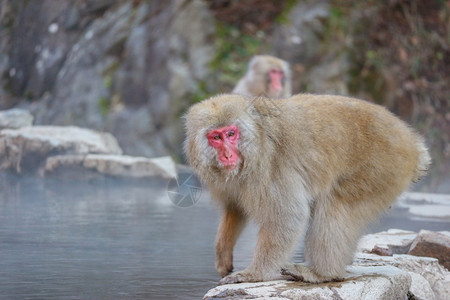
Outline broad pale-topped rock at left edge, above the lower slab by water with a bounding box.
[0,126,122,173]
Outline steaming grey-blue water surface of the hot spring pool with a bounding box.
[0,176,450,299]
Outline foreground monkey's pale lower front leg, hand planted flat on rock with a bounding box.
[219,222,299,284]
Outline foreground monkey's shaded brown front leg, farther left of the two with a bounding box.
[216,207,246,277]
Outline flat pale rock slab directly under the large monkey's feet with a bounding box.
[203,266,411,300]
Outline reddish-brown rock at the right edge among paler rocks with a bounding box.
[408,230,450,270]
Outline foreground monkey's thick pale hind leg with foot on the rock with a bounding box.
[282,199,370,283]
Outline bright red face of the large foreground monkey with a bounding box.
[206,125,239,170]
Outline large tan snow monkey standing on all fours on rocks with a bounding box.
[184,94,430,284]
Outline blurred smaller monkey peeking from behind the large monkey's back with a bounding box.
[233,55,291,98]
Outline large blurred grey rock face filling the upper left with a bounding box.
[0,0,215,157]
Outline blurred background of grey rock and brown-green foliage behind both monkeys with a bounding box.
[0,0,450,188]
